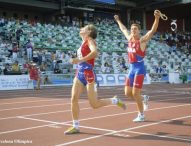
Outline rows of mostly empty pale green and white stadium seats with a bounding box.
[0,16,191,73]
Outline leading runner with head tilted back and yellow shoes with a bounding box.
[65,24,126,134]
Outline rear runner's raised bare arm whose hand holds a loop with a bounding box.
[141,10,160,42]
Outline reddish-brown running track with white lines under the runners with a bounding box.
[0,84,191,146]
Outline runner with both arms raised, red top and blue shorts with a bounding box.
[114,10,161,122]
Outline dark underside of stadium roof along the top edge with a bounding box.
[0,0,191,10]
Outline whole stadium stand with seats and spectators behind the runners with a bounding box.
[0,1,191,88]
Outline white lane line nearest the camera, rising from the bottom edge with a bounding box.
[55,115,191,146]
